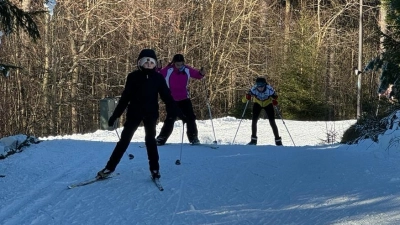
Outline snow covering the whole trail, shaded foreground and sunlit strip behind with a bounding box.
[0,117,400,225]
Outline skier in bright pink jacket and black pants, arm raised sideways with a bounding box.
[156,54,205,145]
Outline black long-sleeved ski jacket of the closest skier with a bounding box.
[112,70,176,120]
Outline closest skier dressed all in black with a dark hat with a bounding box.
[97,49,176,178]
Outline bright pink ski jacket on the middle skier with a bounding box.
[158,65,203,101]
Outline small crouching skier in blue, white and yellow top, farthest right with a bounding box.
[242,77,282,145]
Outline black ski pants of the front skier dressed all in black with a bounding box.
[106,117,160,171]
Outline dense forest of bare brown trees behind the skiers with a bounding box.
[0,0,394,137]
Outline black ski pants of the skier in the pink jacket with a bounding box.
[158,99,198,142]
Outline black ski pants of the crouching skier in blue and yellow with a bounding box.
[251,103,279,139]
